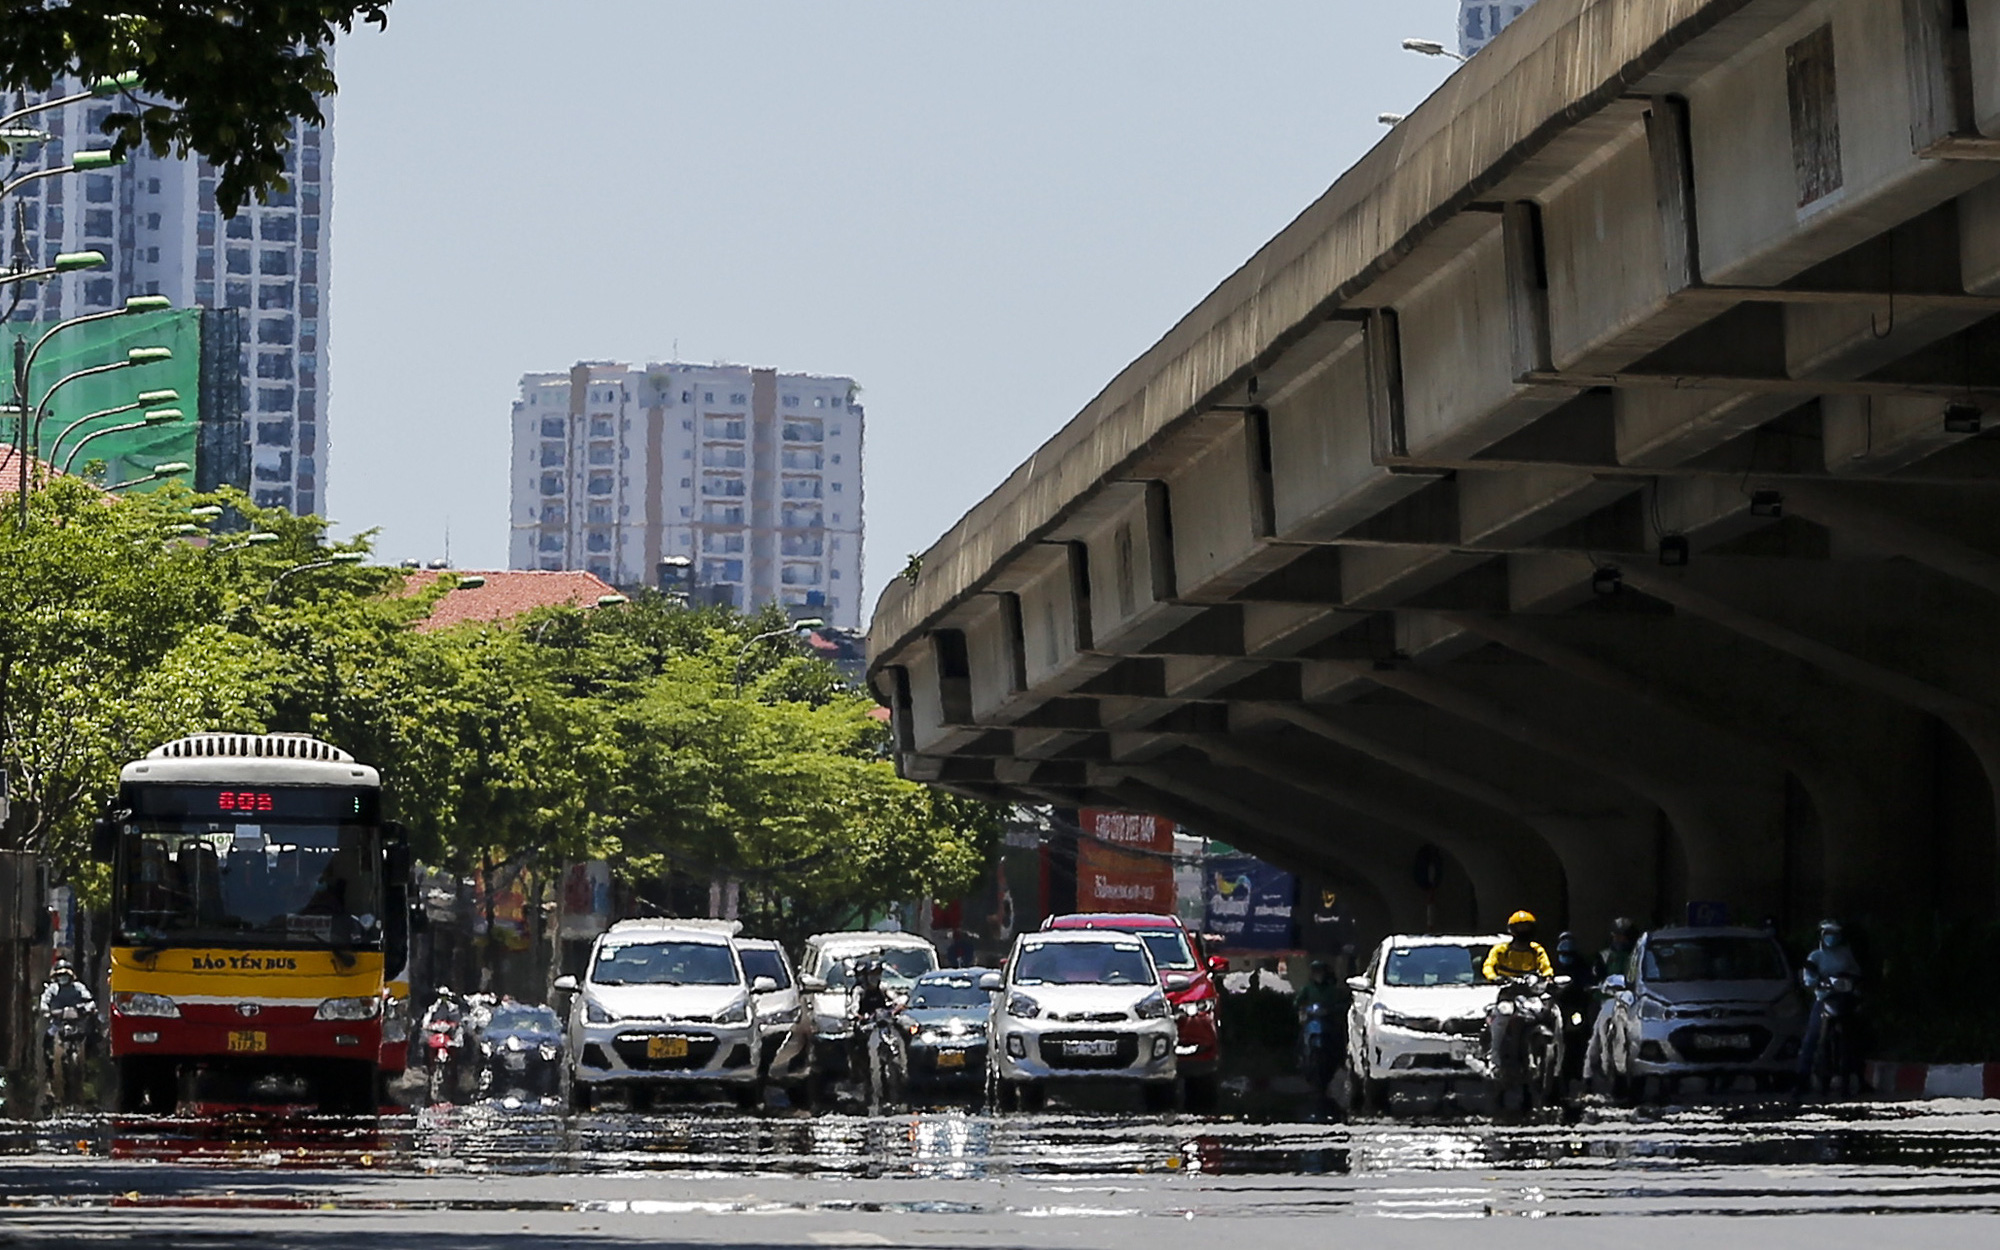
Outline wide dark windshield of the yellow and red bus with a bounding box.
[112,818,382,948]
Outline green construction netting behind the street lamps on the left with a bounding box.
[0,308,202,490]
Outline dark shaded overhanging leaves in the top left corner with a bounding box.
[0,0,390,214]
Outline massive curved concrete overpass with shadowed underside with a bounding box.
[870,0,2000,930]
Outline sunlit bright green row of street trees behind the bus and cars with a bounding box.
[0,480,998,934]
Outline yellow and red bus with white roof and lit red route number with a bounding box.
[98,732,408,1114]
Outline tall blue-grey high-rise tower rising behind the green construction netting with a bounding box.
[0,82,334,512]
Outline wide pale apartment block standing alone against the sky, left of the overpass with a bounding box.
[508,362,862,628]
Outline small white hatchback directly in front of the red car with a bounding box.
[980,928,1188,1110]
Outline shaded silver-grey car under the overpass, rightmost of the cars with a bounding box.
[1594,928,1806,1096]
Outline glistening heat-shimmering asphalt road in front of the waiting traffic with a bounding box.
[0,1102,2000,1250]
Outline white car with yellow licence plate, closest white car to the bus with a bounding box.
[556,920,776,1110]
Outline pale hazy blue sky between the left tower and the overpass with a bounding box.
[324,0,1458,610]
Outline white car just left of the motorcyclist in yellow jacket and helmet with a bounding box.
[1348,934,1508,1110]
